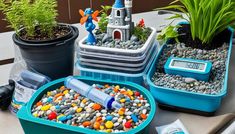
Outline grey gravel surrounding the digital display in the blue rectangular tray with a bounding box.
[152,43,229,95]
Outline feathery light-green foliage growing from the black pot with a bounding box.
[0,0,57,36]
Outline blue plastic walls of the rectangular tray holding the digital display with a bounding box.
[147,28,233,113]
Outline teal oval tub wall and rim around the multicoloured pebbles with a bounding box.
[17,77,156,134]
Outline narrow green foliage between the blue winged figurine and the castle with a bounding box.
[98,6,112,33]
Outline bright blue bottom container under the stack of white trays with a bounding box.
[75,46,158,85]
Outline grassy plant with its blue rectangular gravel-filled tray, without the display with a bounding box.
[147,0,235,114]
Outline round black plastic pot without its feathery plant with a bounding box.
[12,26,79,80]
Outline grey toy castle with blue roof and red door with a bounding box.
[107,0,134,41]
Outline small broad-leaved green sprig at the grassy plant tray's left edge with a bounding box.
[157,25,180,42]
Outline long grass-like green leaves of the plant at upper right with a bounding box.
[157,0,235,44]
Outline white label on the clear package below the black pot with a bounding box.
[14,82,36,103]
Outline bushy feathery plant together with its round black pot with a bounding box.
[0,0,78,79]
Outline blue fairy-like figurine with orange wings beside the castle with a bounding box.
[79,8,99,45]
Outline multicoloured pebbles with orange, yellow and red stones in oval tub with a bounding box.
[32,84,150,133]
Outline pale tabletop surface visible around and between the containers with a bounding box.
[0,11,235,134]
